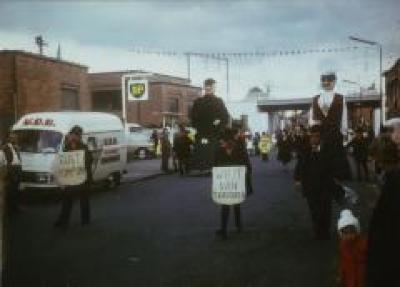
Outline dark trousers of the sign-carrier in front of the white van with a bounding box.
[57,185,90,224]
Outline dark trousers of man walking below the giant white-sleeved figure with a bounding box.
[307,195,332,239]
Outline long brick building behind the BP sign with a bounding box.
[89,71,201,127]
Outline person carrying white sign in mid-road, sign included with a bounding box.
[213,128,252,240]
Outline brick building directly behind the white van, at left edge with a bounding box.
[0,50,91,141]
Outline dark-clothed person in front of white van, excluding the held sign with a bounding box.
[54,126,93,228]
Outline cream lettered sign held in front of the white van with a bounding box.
[57,150,87,188]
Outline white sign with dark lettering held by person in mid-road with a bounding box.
[212,166,246,205]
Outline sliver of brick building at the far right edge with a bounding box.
[384,59,400,119]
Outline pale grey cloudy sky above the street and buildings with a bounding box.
[0,0,400,101]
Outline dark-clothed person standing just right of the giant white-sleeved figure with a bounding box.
[347,129,369,181]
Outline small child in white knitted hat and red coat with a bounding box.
[338,209,367,287]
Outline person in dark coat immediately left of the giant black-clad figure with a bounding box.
[173,125,192,175]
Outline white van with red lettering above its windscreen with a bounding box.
[13,112,127,189]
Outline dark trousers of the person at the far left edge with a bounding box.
[6,166,21,213]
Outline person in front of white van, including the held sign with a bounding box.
[54,126,92,228]
